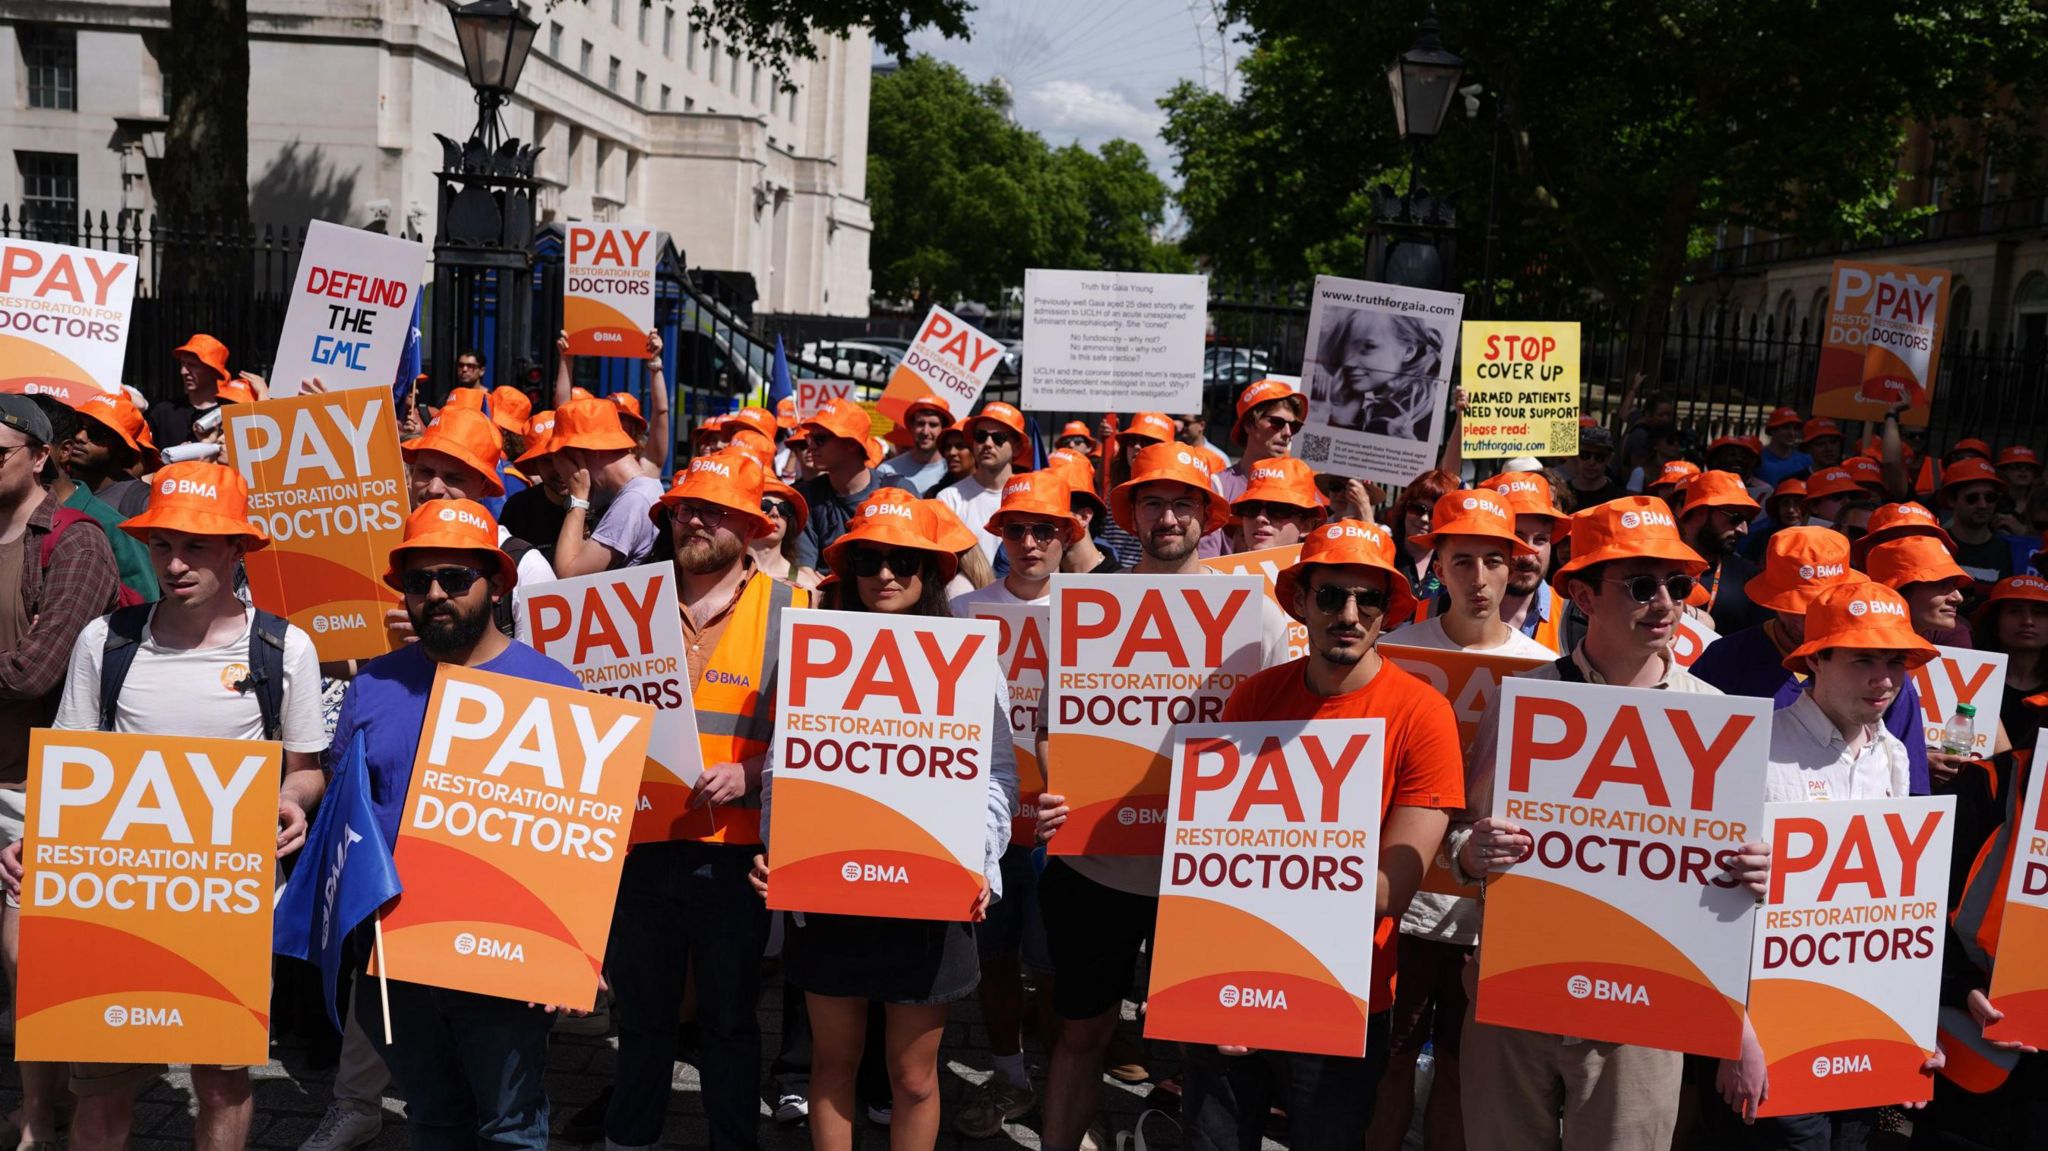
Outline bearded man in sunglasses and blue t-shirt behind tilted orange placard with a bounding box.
[328,499,585,1147]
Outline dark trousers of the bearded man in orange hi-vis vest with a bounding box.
[604,840,768,1151]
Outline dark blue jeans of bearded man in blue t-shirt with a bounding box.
[356,977,555,1151]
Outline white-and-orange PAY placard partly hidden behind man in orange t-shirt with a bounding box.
[1047,573,1266,856]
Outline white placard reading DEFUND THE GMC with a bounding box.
[270,219,426,397]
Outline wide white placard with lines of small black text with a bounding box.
[1022,268,1208,412]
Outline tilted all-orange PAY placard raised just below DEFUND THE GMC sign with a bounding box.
[227,387,410,659]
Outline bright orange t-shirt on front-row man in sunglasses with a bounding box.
[1221,657,1464,1012]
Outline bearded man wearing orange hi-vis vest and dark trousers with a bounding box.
[604,449,811,1151]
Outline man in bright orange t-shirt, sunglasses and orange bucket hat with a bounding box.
[1182,520,1464,1151]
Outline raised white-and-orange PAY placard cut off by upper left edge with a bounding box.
[0,238,135,408]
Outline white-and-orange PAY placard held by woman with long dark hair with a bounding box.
[766,608,1001,920]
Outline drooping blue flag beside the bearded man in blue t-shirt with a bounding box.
[270,735,399,1030]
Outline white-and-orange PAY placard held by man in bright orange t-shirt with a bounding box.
[1145,719,1386,1059]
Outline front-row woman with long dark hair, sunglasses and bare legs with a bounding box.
[754,489,1018,1151]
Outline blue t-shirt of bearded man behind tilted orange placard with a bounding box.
[328,639,584,844]
